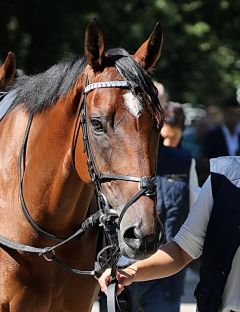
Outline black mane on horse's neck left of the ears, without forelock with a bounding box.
[9,56,86,114]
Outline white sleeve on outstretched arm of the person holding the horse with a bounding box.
[173,177,213,258]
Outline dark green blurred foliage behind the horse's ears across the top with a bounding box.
[0,0,240,105]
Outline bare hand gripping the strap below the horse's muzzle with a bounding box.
[98,265,137,294]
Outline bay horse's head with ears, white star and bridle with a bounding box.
[75,21,164,259]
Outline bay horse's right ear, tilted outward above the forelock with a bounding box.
[133,23,163,70]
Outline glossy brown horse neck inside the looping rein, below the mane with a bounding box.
[24,96,92,234]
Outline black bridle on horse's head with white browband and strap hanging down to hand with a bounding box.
[73,81,156,312]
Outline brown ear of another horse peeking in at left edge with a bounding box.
[0,51,16,91]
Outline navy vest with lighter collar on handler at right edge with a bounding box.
[194,156,240,312]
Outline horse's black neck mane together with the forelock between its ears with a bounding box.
[10,48,163,123]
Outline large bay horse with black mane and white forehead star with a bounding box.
[0,21,164,312]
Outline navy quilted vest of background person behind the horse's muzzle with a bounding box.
[157,146,192,296]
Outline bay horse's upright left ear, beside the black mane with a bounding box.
[85,19,104,72]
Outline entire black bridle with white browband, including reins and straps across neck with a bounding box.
[0,80,155,310]
